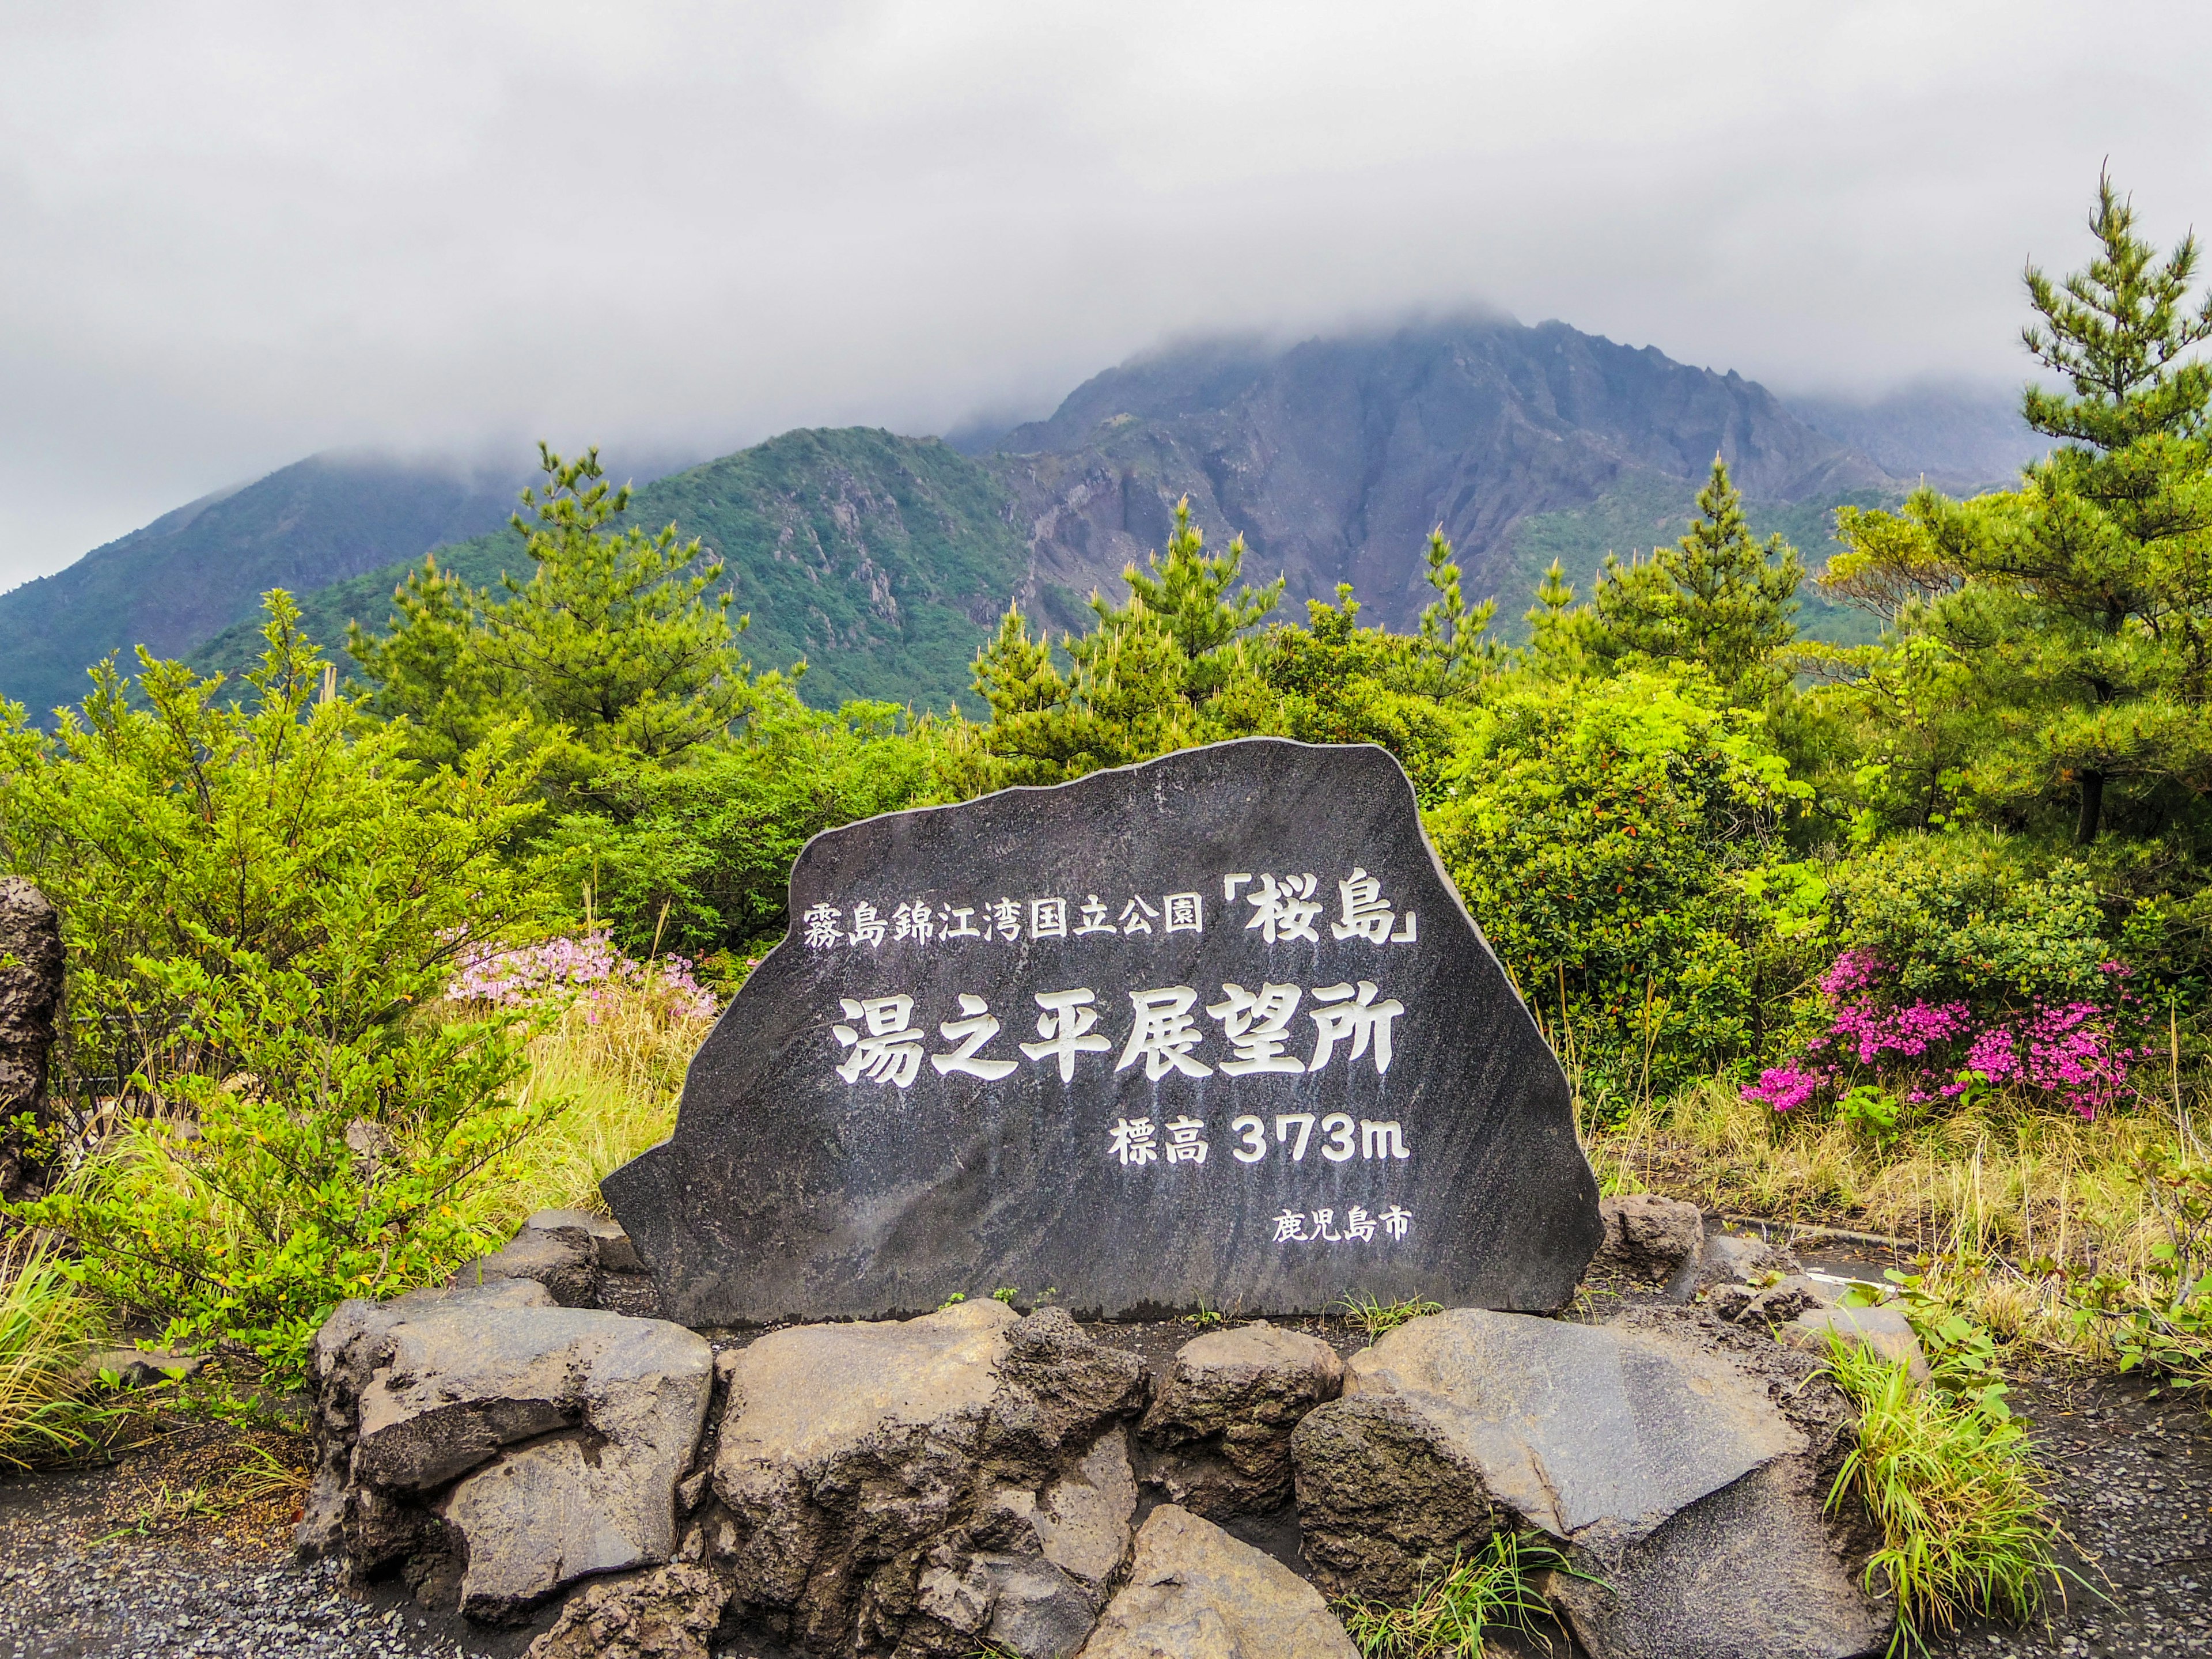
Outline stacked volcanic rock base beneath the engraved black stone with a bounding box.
[301,1214,1891,1659]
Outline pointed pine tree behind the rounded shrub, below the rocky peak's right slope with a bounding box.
[1590,456,1805,706]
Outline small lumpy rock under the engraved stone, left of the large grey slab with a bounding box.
[1139,1320,1345,1520]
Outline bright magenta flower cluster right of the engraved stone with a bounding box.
[1743,951,2139,1117]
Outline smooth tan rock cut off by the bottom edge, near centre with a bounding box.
[1082,1504,1356,1659]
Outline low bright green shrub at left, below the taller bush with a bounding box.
[16,951,558,1382]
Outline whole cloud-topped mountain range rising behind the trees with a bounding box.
[17,314,1937,725]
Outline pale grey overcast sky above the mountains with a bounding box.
[0,0,2212,588]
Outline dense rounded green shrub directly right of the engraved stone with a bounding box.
[1429,671,1827,1101]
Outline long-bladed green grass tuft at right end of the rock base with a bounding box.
[1827,1338,2059,1654]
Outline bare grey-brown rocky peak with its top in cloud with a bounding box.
[987,316,1889,628]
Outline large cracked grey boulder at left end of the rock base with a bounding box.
[298,1279,712,1619]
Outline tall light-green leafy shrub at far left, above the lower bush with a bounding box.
[0,590,542,1097]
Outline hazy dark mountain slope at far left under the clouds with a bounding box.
[0,453,522,714]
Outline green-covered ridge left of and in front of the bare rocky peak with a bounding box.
[192,427,1027,708]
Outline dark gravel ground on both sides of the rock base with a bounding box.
[0,1354,2212,1659]
